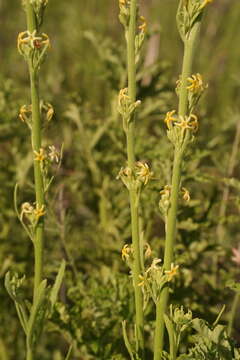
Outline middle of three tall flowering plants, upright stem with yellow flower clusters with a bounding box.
[118,0,149,359]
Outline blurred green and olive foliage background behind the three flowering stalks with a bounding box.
[0,0,240,360]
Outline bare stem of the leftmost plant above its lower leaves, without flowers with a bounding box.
[26,1,44,301]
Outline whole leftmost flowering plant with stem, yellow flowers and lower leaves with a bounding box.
[5,0,65,360]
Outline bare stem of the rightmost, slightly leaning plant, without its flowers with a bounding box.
[154,21,200,360]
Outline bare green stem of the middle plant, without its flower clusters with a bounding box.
[127,0,144,359]
